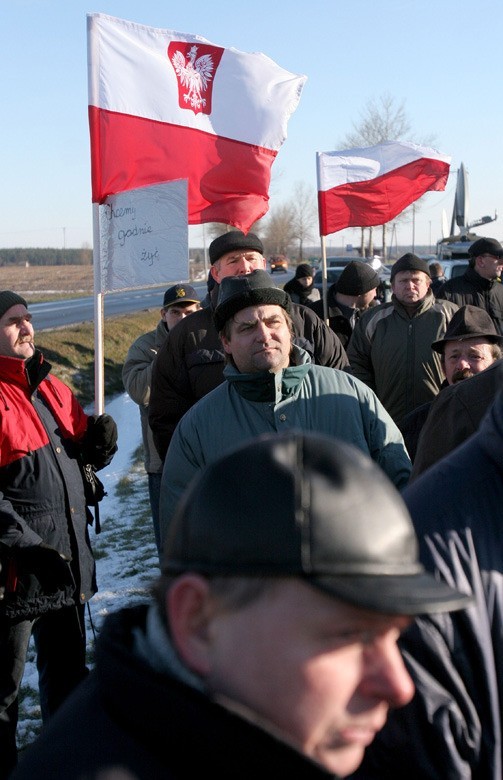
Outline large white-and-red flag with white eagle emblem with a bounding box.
[87,14,306,231]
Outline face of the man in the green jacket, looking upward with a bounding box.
[221,304,292,374]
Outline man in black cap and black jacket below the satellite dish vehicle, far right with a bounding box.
[437,238,503,334]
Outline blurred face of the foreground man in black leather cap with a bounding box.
[206,579,414,777]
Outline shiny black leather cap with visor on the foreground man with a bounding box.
[162,431,470,615]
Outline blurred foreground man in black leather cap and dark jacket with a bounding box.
[12,431,469,780]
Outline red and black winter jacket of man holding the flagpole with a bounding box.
[0,352,97,618]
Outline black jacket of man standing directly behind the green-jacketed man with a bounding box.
[148,296,349,460]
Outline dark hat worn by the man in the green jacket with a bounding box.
[213,269,291,332]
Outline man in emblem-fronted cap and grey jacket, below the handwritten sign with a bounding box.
[122,284,201,555]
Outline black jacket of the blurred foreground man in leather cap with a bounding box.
[11,608,334,780]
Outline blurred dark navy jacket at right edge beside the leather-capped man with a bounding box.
[355,394,503,780]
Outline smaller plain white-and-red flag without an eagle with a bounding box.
[317,141,451,236]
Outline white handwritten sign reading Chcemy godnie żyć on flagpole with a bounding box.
[99,179,189,293]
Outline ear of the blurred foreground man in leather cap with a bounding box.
[166,574,212,677]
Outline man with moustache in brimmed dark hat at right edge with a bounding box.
[399,306,503,463]
